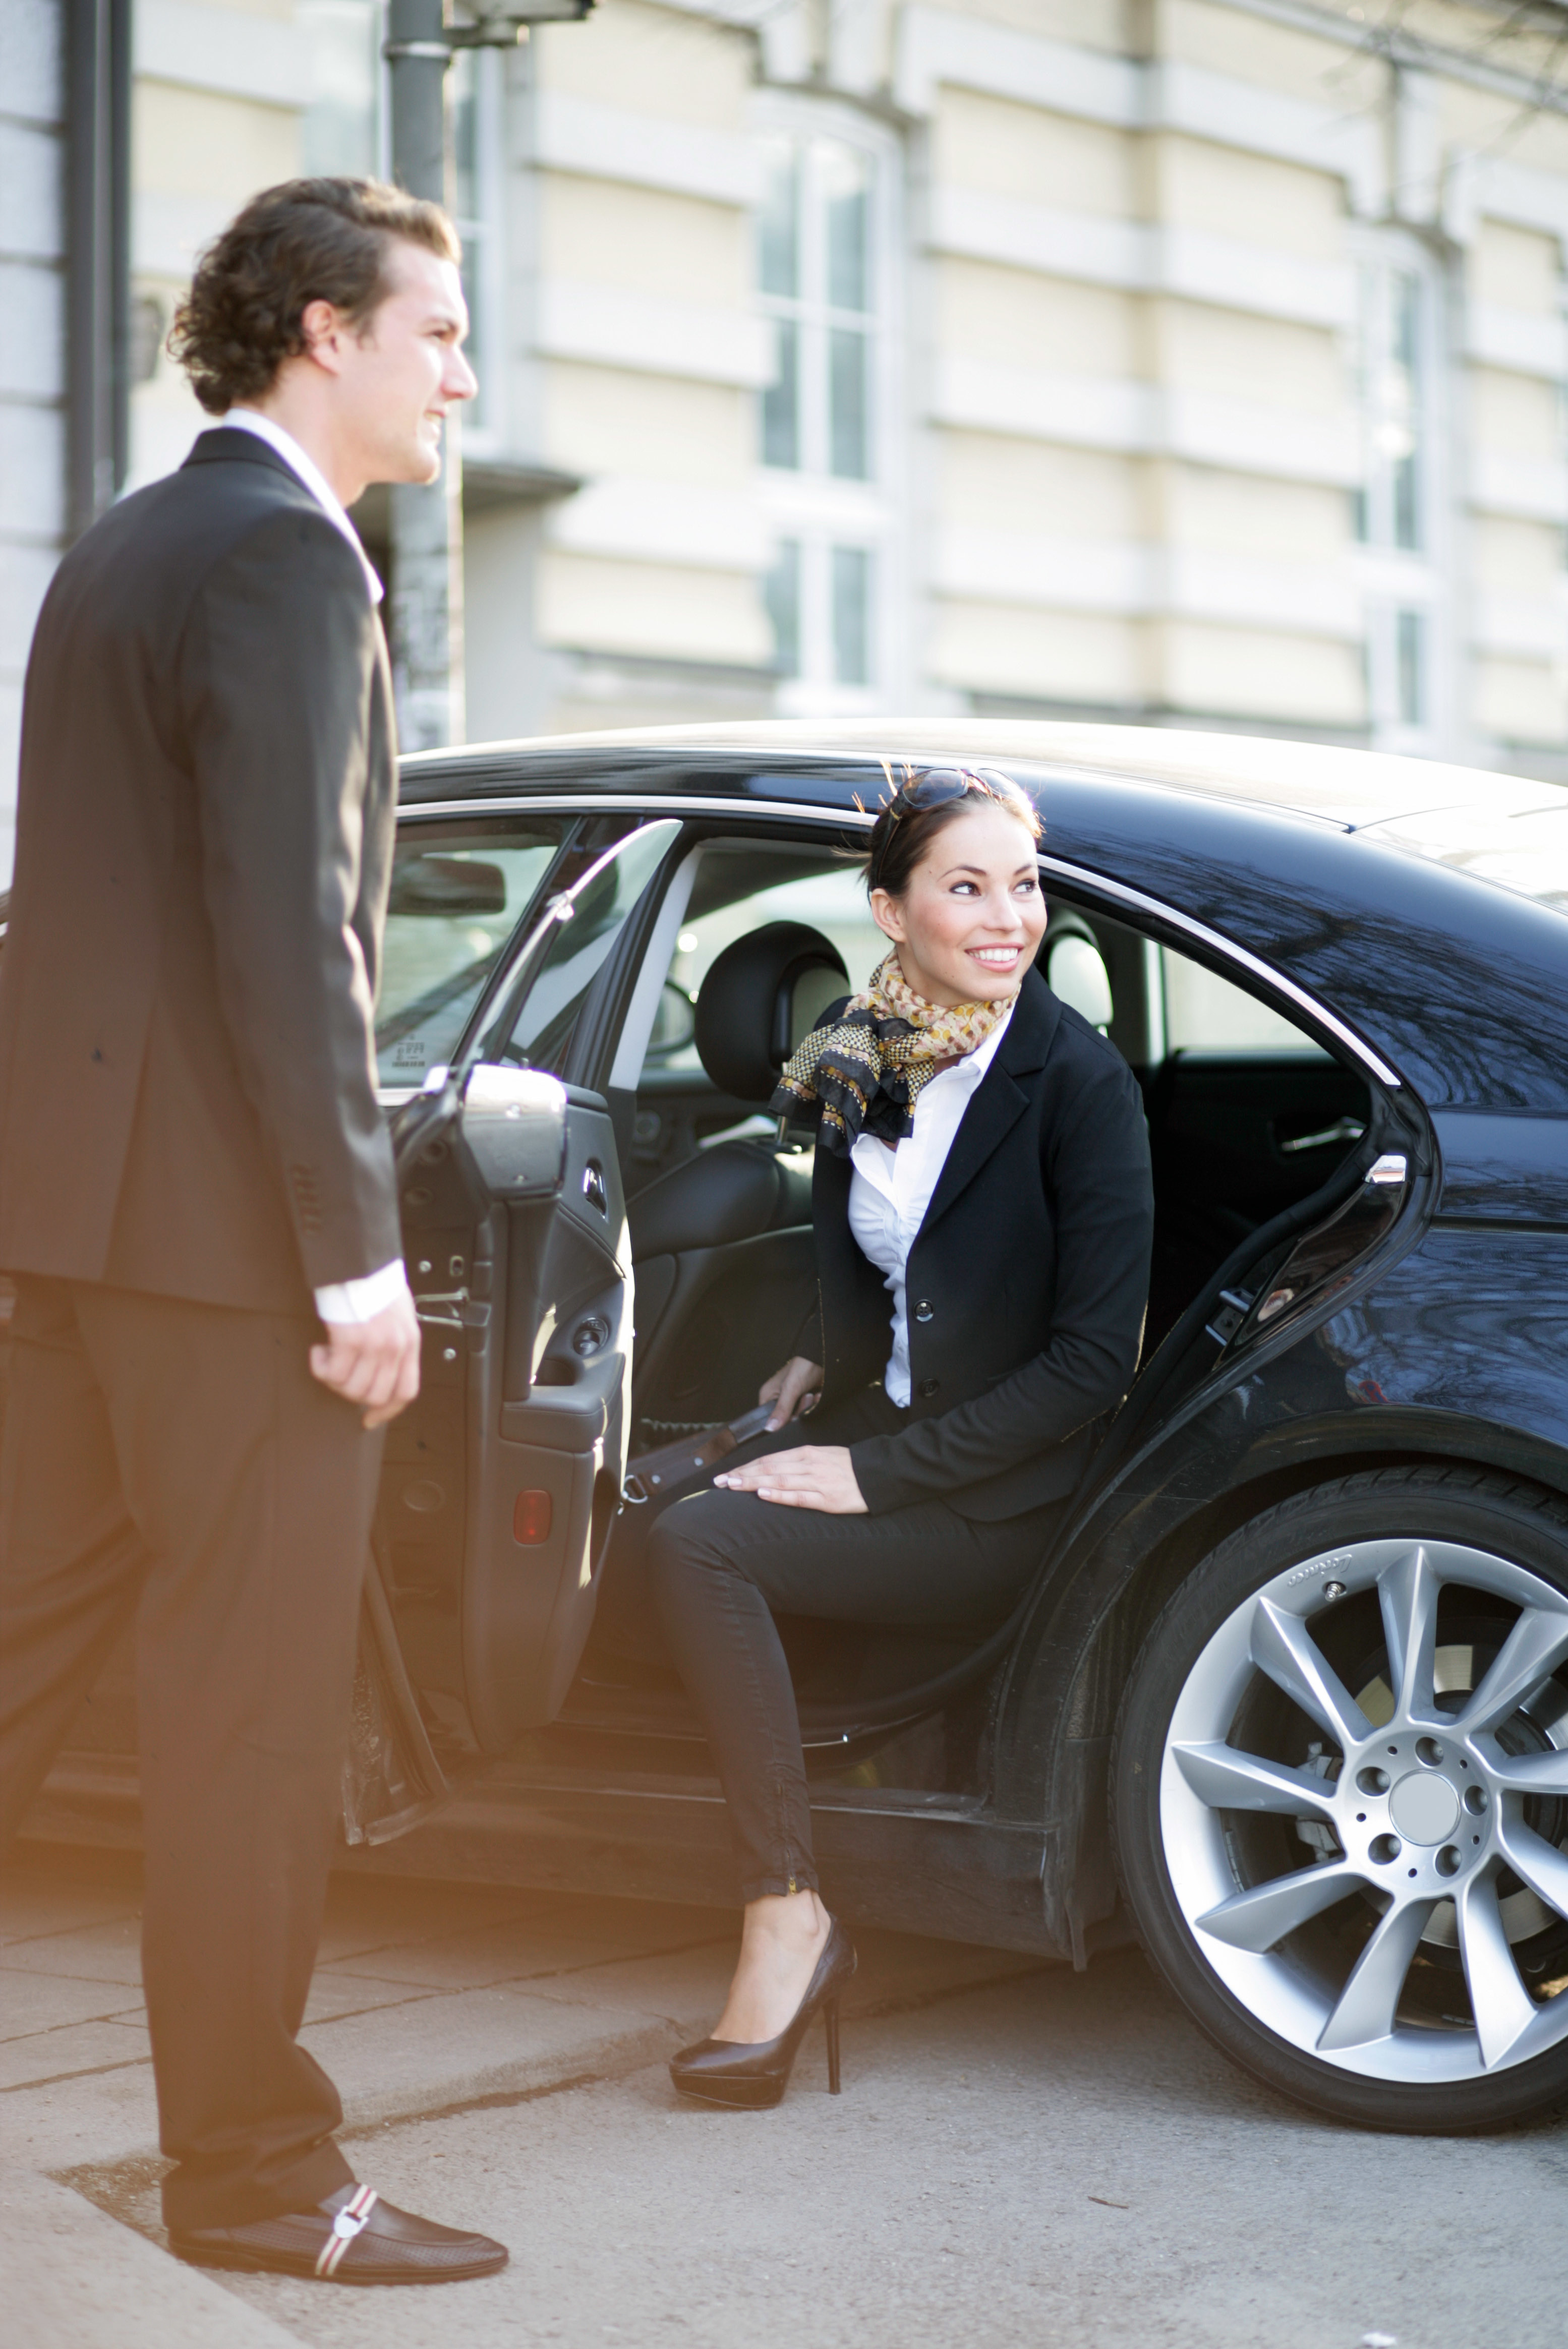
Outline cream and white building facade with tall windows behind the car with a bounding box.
[0,0,1568,883]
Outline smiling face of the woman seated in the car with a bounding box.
[872,799,1046,1003]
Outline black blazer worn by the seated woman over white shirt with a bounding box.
[799,970,1154,1520]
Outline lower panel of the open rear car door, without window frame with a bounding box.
[381,1067,632,1752]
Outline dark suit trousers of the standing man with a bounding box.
[0,1275,381,2227]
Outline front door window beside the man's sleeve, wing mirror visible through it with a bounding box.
[376,815,573,1092]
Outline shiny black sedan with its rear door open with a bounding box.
[9,721,1568,2131]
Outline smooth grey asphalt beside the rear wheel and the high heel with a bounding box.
[95,1952,1568,2349]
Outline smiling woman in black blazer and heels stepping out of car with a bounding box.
[616,768,1152,2105]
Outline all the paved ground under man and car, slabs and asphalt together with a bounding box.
[12,1846,1568,2349]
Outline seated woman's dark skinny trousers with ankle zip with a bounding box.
[628,1388,1063,1900]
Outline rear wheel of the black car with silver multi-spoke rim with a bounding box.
[1112,1466,1568,2133]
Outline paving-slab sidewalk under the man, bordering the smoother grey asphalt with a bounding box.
[0,1844,1053,2349]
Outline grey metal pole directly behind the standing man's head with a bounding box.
[385,0,466,749]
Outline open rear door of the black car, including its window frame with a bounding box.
[367,822,679,1776]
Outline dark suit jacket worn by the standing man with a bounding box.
[0,430,402,1311]
